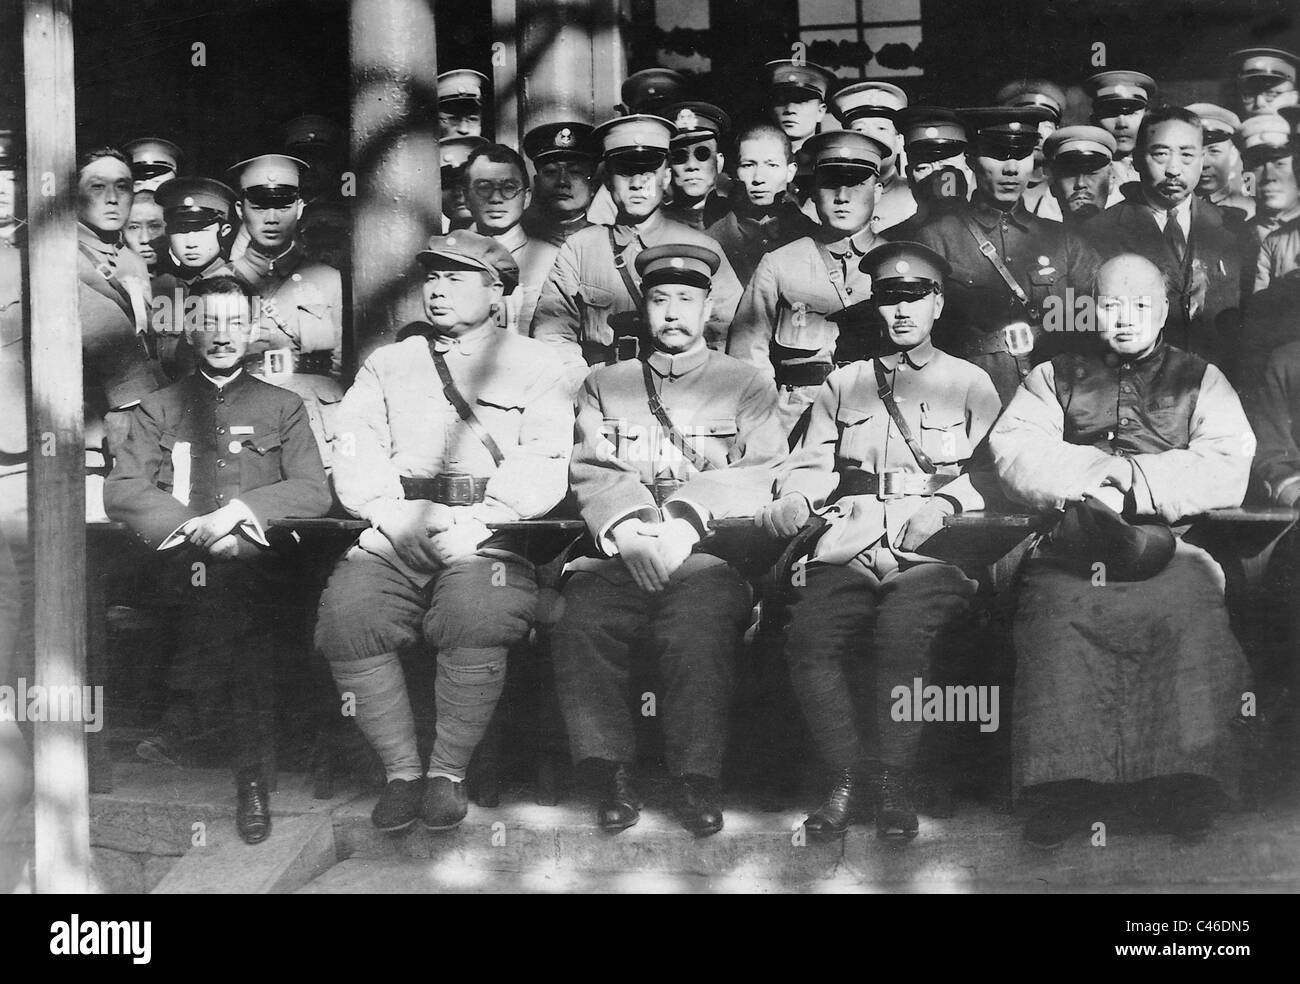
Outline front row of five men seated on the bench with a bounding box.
[98,231,1253,844]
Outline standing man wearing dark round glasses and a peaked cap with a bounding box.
[663,103,731,231]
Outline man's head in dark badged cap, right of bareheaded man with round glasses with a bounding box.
[524,121,597,244]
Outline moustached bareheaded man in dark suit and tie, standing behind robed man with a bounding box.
[1087,107,1243,376]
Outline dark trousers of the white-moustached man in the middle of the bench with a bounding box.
[551,554,750,779]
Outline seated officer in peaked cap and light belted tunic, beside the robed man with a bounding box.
[755,243,1001,840]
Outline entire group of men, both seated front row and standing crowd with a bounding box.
[0,42,1300,846]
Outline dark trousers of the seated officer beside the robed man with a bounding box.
[785,563,976,772]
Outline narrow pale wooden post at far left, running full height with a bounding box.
[22,0,90,893]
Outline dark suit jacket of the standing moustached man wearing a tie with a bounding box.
[1076,186,1243,372]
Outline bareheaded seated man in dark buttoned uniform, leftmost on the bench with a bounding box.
[104,276,330,844]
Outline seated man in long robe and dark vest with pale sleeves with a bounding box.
[989,253,1253,846]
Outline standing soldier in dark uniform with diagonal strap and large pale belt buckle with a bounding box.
[917,107,1097,400]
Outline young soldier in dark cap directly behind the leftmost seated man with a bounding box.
[150,178,237,380]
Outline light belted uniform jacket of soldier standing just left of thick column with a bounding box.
[231,243,343,467]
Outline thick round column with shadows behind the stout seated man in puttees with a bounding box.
[350,0,442,361]
